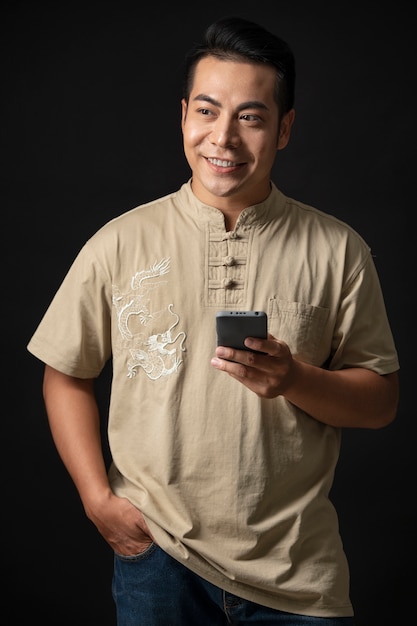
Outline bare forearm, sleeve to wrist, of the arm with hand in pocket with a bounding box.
[43,366,110,515]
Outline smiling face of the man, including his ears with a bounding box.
[182,57,293,209]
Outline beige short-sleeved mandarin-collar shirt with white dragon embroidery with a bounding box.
[28,182,399,617]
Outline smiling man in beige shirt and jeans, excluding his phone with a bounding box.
[28,18,399,626]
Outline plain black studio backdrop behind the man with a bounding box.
[0,0,417,626]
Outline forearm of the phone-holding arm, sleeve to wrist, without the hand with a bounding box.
[283,361,398,428]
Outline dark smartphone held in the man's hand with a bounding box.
[216,311,268,350]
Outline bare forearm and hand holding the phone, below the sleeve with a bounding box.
[211,335,399,428]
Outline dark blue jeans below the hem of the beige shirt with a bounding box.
[112,544,354,626]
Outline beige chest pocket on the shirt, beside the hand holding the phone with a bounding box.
[268,298,332,366]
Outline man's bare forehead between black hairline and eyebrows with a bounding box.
[190,56,276,104]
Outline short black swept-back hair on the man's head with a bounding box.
[183,17,295,115]
